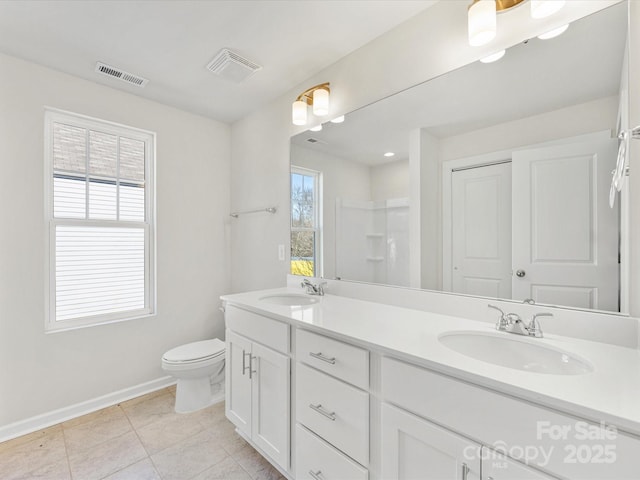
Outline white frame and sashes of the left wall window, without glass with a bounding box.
[44,107,157,333]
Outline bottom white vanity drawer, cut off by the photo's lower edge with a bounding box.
[295,425,369,480]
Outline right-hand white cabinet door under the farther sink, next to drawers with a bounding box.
[251,343,290,469]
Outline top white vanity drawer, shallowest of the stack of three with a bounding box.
[296,330,369,389]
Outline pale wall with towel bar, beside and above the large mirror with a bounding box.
[231,0,617,291]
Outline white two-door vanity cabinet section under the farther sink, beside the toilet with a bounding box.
[225,307,290,470]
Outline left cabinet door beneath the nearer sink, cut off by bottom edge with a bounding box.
[382,403,480,480]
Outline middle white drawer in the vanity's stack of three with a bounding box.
[296,363,369,465]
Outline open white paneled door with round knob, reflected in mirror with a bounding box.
[512,139,619,311]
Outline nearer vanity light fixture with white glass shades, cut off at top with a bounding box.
[468,0,565,47]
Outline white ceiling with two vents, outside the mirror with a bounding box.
[0,0,436,123]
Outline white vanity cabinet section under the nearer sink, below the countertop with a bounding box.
[382,357,640,480]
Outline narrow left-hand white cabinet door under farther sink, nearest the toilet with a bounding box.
[225,330,252,437]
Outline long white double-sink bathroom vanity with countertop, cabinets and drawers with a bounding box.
[223,288,640,480]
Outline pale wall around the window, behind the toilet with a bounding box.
[0,55,231,428]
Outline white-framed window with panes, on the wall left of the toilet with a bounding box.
[45,110,155,331]
